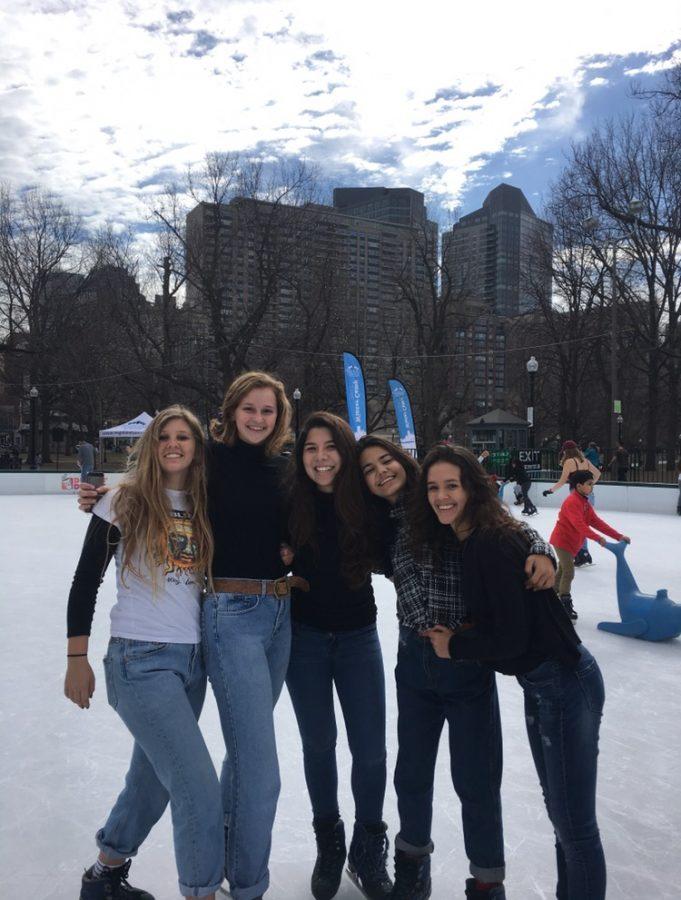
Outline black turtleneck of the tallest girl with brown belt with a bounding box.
[208,440,286,580]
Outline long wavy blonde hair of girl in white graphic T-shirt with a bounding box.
[112,406,213,588]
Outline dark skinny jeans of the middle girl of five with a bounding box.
[286,623,386,825]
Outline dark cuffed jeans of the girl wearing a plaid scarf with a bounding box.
[395,627,504,882]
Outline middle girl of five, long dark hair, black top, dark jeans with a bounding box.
[286,412,392,900]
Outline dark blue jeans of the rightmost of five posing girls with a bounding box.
[518,645,605,900]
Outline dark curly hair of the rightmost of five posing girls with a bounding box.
[409,444,522,560]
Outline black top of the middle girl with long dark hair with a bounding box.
[291,491,376,631]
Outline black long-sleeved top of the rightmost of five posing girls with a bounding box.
[449,531,581,675]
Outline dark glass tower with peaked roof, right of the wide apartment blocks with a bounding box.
[443,184,553,316]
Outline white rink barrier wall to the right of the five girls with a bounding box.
[524,481,679,516]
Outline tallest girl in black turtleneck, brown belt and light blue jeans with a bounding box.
[201,372,291,900]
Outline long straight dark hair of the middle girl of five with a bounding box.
[289,411,379,588]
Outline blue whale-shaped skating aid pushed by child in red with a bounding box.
[598,541,681,641]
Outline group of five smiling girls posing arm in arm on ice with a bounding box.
[65,373,604,900]
